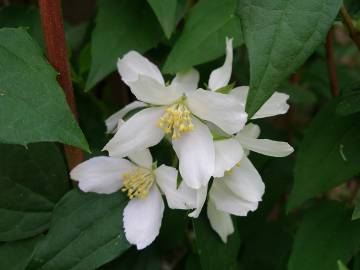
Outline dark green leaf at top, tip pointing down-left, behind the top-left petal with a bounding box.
[86,0,162,90]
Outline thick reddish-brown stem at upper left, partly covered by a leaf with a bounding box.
[39,0,84,169]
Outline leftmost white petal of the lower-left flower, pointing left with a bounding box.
[70,157,135,194]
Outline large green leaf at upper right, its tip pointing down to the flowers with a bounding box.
[238,0,342,117]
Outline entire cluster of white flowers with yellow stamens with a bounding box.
[71,39,293,249]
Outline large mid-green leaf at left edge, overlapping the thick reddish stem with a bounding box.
[0,28,88,150]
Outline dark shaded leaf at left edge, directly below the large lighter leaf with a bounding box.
[0,143,69,241]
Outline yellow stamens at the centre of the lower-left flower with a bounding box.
[121,168,155,199]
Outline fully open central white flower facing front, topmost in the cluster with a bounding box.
[104,39,247,189]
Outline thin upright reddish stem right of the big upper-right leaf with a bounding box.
[326,27,340,97]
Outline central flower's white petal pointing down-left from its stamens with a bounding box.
[104,107,164,157]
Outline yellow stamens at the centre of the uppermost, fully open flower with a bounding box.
[158,102,194,140]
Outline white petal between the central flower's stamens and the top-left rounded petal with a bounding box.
[129,75,182,105]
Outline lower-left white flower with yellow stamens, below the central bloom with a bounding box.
[70,149,196,249]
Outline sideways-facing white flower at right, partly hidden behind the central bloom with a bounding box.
[197,86,294,242]
